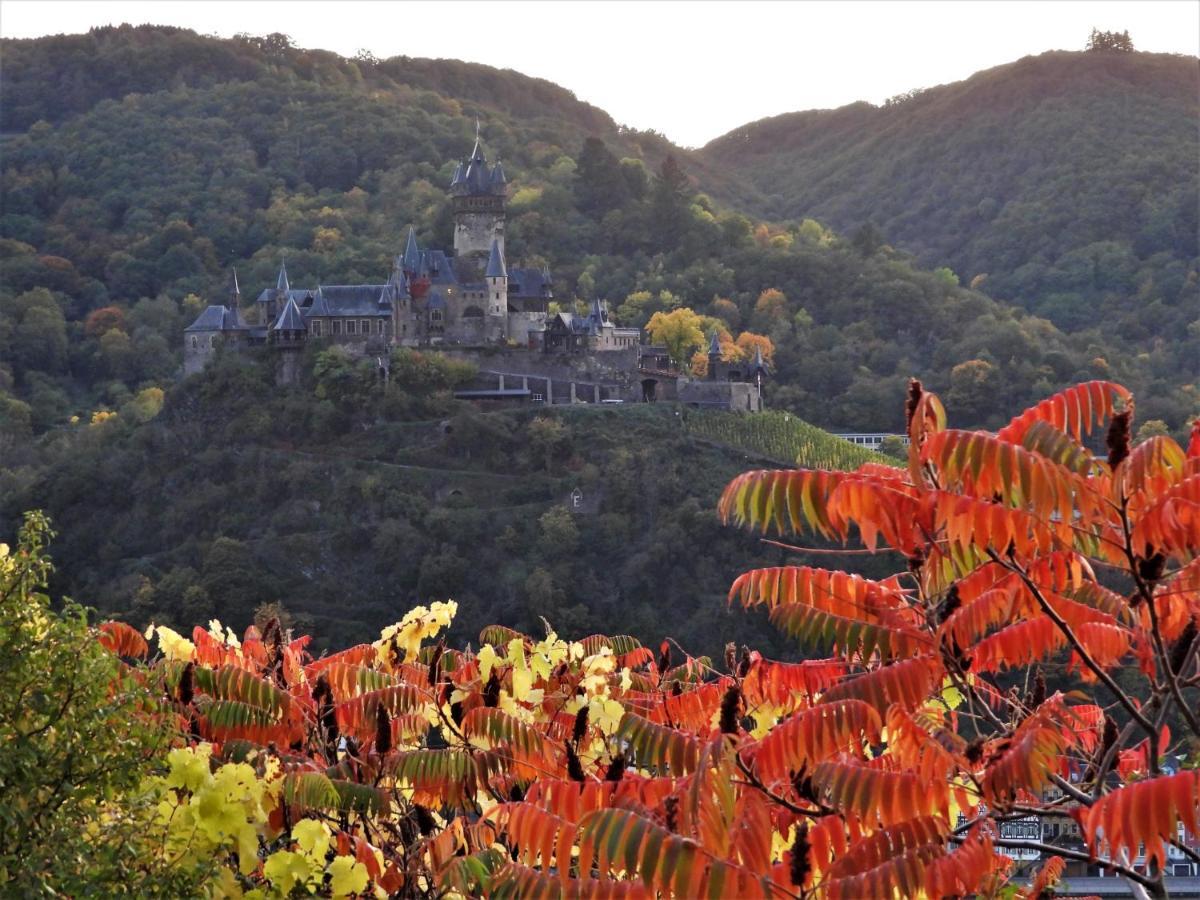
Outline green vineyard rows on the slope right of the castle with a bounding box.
[684,409,896,469]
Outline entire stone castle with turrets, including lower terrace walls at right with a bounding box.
[184,122,767,412]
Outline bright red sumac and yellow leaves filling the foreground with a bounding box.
[93,382,1200,898]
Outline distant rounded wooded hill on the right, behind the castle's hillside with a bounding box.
[700,52,1200,347]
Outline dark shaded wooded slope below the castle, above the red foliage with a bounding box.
[0,350,863,654]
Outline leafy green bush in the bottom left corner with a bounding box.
[0,512,209,898]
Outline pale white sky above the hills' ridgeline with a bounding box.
[0,0,1200,146]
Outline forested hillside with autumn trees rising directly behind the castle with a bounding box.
[0,26,1200,444]
